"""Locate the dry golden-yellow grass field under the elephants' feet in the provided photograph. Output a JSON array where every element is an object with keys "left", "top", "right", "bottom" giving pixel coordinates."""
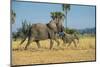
[{"left": 12, "top": 37, "right": 96, "bottom": 65}]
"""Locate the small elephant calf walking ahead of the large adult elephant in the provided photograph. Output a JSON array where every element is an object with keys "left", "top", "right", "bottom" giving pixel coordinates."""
[{"left": 61, "top": 32, "right": 79, "bottom": 47}]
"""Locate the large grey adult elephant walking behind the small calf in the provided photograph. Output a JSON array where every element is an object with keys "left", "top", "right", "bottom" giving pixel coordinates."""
[{"left": 20, "top": 19, "right": 64, "bottom": 50}]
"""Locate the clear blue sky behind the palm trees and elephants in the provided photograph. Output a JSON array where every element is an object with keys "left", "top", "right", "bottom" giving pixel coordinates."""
[{"left": 11, "top": 1, "right": 95, "bottom": 31}]
